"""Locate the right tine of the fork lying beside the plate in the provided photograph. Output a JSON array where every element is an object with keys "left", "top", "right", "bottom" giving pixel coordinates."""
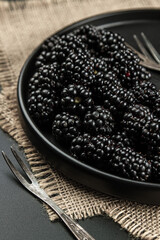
[{"left": 11, "top": 147, "right": 35, "bottom": 182}]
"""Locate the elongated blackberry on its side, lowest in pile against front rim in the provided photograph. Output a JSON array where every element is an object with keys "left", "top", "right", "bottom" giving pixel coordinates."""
[{"left": 108, "top": 147, "right": 151, "bottom": 181}]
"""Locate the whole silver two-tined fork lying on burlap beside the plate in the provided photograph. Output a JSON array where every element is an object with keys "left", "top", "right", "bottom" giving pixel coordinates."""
[{"left": 2, "top": 147, "right": 95, "bottom": 240}]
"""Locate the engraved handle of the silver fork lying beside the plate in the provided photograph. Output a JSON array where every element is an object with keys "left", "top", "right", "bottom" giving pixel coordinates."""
[{"left": 38, "top": 194, "right": 95, "bottom": 240}]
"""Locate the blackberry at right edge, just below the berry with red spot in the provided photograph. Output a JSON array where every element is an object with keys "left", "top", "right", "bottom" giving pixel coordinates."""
[{"left": 133, "top": 81, "right": 158, "bottom": 107}]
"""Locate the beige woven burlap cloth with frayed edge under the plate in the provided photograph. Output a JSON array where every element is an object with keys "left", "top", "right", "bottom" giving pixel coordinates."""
[{"left": 0, "top": 0, "right": 160, "bottom": 240}]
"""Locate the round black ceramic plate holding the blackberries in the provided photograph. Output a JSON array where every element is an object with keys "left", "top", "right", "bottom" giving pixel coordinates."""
[{"left": 18, "top": 10, "right": 160, "bottom": 204}]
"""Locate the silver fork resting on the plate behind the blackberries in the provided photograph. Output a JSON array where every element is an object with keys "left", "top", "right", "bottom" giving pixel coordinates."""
[{"left": 126, "top": 32, "right": 160, "bottom": 71}]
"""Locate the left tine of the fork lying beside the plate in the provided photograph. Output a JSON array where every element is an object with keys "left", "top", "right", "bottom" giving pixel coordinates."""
[{"left": 2, "top": 151, "right": 30, "bottom": 189}]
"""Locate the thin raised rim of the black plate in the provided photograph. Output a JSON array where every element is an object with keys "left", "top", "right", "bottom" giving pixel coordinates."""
[{"left": 17, "top": 8, "right": 160, "bottom": 193}]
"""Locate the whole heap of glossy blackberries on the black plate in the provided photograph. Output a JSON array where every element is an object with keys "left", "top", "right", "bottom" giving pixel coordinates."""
[{"left": 27, "top": 25, "right": 160, "bottom": 182}]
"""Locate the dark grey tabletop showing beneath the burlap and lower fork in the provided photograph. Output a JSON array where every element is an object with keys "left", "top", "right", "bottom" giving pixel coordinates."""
[{"left": 0, "top": 130, "right": 131, "bottom": 240}]
